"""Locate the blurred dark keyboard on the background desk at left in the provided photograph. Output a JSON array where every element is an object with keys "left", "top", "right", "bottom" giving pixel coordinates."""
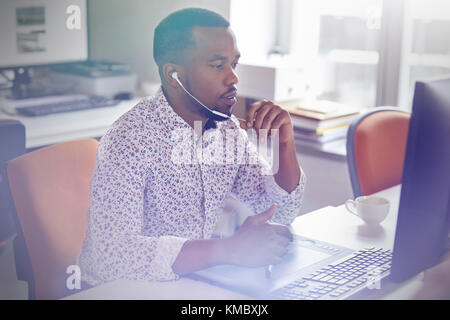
[{"left": 15, "top": 96, "right": 120, "bottom": 117}]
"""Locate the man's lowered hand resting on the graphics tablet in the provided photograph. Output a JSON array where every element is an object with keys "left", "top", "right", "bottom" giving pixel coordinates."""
[{"left": 225, "top": 205, "right": 293, "bottom": 267}]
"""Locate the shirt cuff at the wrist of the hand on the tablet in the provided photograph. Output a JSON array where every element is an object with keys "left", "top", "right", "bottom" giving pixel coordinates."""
[{"left": 150, "top": 236, "right": 188, "bottom": 280}]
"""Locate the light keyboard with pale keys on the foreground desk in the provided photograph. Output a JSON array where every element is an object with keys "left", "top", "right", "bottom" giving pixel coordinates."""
[{"left": 267, "top": 248, "right": 392, "bottom": 300}]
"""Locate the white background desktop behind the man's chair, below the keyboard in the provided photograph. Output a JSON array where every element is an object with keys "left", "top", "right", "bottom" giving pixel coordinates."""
[{"left": 0, "top": 98, "right": 141, "bottom": 149}]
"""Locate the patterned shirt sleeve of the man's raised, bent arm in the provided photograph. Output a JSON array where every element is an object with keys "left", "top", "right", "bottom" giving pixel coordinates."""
[{"left": 233, "top": 127, "right": 306, "bottom": 225}]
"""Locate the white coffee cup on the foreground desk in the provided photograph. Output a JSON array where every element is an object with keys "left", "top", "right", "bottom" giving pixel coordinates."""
[{"left": 345, "top": 196, "right": 390, "bottom": 225}]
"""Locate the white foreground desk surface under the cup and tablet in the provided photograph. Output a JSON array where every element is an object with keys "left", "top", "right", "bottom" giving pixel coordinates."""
[{"left": 66, "top": 186, "right": 421, "bottom": 300}]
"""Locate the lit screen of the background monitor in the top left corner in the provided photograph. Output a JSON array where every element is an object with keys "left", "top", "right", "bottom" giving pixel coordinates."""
[{"left": 0, "top": 0, "right": 88, "bottom": 69}]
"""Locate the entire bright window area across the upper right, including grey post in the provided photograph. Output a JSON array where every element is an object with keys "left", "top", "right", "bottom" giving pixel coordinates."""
[{"left": 231, "top": 0, "right": 450, "bottom": 110}]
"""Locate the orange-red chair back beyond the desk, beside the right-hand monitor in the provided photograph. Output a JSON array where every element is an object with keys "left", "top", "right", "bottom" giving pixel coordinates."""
[{"left": 347, "top": 107, "right": 410, "bottom": 198}]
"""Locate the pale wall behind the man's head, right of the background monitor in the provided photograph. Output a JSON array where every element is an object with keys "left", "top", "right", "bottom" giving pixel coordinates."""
[{"left": 88, "top": 0, "right": 230, "bottom": 86}]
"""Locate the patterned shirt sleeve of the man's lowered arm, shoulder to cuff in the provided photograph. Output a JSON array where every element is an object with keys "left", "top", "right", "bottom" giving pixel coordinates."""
[{"left": 78, "top": 128, "right": 187, "bottom": 285}]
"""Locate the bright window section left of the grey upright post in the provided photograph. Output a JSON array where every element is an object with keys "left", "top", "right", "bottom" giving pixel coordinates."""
[{"left": 290, "top": 0, "right": 382, "bottom": 107}]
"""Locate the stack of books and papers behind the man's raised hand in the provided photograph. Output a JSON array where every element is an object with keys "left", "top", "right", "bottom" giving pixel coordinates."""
[{"left": 282, "top": 101, "right": 360, "bottom": 149}]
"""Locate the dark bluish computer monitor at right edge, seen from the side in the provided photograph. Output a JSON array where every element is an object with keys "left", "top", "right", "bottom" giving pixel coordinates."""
[{"left": 390, "top": 76, "right": 450, "bottom": 282}]
